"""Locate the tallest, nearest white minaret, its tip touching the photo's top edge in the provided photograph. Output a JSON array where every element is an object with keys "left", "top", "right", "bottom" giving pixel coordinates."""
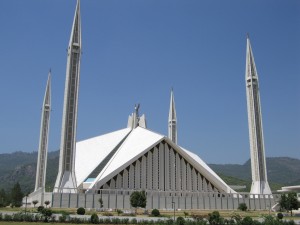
[{"left": 54, "top": 0, "right": 81, "bottom": 193}]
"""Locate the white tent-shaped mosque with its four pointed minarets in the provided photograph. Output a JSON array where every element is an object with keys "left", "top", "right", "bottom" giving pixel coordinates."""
[{"left": 24, "top": 0, "right": 272, "bottom": 208}]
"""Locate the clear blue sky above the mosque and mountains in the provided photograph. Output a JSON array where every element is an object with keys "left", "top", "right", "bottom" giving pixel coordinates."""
[{"left": 0, "top": 0, "right": 300, "bottom": 163}]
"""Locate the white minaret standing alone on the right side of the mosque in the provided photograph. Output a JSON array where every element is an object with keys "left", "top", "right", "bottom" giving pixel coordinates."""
[{"left": 246, "top": 35, "right": 272, "bottom": 194}]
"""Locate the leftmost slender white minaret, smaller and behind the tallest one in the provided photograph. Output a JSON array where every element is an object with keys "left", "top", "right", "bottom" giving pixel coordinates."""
[{"left": 34, "top": 70, "right": 51, "bottom": 195}]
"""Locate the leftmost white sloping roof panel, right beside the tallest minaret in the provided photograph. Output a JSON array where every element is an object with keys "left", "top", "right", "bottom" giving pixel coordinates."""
[{"left": 75, "top": 128, "right": 131, "bottom": 185}]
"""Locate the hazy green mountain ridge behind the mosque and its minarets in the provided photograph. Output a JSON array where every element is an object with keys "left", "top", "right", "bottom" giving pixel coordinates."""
[{"left": 0, "top": 151, "right": 300, "bottom": 193}]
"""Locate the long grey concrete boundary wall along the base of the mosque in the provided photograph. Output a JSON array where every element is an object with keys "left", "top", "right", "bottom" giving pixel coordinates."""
[{"left": 51, "top": 189, "right": 280, "bottom": 210}]
